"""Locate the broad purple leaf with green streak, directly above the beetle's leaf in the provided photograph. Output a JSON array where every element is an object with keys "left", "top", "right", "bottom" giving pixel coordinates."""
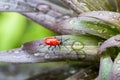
[{"left": 55, "top": 11, "right": 120, "bottom": 39}]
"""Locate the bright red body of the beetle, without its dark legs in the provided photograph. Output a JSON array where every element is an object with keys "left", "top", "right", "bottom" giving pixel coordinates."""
[{"left": 45, "top": 37, "right": 61, "bottom": 46}]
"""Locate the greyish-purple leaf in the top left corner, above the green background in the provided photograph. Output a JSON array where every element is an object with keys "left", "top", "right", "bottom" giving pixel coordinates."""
[{"left": 0, "top": 0, "right": 38, "bottom": 12}]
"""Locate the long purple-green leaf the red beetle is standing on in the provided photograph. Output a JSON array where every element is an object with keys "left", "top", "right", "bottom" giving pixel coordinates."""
[{"left": 0, "top": 35, "right": 102, "bottom": 63}]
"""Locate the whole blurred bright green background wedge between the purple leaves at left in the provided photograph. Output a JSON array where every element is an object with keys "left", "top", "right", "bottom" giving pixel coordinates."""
[{"left": 0, "top": 12, "right": 56, "bottom": 50}]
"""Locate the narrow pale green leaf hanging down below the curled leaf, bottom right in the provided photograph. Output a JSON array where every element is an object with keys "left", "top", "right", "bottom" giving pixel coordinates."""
[{"left": 98, "top": 53, "right": 113, "bottom": 80}]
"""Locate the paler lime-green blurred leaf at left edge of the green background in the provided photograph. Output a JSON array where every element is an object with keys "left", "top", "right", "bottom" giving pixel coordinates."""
[{"left": 0, "top": 13, "right": 27, "bottom": 50}]
